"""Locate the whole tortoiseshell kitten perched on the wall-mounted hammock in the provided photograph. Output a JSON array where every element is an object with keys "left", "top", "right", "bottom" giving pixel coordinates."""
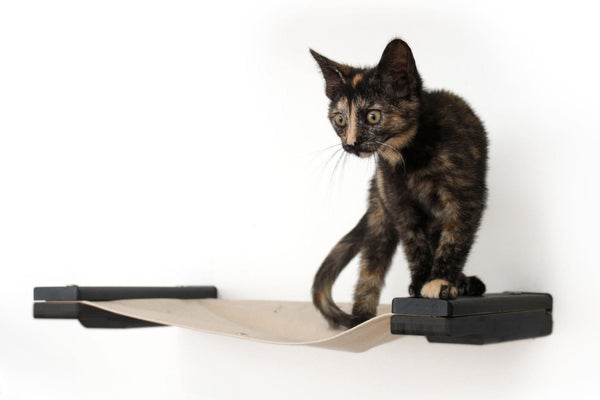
[{"left": 311, "top": 39, "right": 487, "bottom": 327}]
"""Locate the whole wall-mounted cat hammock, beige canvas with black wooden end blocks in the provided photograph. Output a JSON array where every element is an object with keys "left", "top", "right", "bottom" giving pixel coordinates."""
[{"left": 34, "top": 286, "right": 552, "bottom": 352}]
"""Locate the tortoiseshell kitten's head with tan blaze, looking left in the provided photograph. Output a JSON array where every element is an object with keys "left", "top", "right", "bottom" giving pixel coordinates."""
[{"left": 310, "top": 39, "right": 422, "bottom": 160}]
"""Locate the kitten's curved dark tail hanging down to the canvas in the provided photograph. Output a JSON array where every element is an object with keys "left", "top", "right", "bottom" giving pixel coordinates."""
[{"left": 312, "top": 214, "right": 367, "bottom": 328}]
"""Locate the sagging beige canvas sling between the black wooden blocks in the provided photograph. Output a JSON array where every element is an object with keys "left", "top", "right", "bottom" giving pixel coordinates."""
[{"left": 80, "top": 299, "right": 400, "bottom": 352}]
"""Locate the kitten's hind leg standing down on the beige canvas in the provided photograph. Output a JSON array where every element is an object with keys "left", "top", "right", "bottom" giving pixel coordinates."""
[{"left": 352, "top": 196, "right": 398, "bottom": 326}]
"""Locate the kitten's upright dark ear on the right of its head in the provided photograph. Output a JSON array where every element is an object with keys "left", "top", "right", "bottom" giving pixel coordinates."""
[{"left": 376, "top": 39, "right": 422, "bottom": 97}]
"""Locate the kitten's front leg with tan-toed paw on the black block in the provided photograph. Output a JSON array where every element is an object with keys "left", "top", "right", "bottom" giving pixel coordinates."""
[{"left": 421, "top": 190, "right": 485, "bottom": 299}]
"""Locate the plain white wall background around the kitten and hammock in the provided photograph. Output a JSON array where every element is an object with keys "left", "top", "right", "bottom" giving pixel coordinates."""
[{"left": 0, "top": 0, "right": 600, "bottom": 399}]
